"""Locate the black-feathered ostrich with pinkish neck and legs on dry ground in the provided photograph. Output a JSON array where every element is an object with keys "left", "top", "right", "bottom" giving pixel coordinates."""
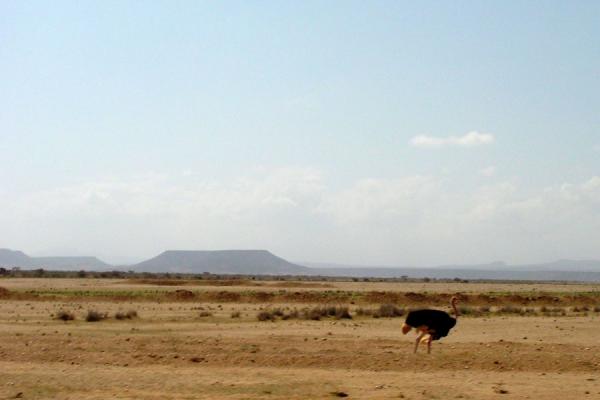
[{"left": 402, "top": 297, "right": 458, "bottom": 354}]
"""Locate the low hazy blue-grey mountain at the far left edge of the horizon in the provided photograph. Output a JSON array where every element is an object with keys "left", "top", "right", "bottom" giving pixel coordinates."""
[{"left": 0, "top": 249, "right": 111, "bottom": 270}]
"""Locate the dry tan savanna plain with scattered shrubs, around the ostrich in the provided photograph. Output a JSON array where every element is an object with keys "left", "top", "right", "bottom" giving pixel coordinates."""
[{"left": 0, "top": 278, "right": 600, "bottom": 399}]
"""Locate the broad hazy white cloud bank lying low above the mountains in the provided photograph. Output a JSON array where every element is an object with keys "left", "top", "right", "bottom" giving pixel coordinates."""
[{"left": 0, "top": 168, "right": 600, "bottom": 265}]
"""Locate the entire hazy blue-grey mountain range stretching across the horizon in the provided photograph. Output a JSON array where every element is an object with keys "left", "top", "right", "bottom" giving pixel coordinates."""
[{"left": 0, "top": 249, "right": 600, "bottom": 282}]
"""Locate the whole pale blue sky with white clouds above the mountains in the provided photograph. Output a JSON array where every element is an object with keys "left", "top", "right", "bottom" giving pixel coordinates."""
[{"left": 0, "top": 1, "right": 600, "bottom": 266}]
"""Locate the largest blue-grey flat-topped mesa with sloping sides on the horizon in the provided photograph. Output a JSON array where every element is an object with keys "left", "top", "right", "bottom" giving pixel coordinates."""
[{"left": 133, "top": 250, "right": 310, "bottom": 275}]
